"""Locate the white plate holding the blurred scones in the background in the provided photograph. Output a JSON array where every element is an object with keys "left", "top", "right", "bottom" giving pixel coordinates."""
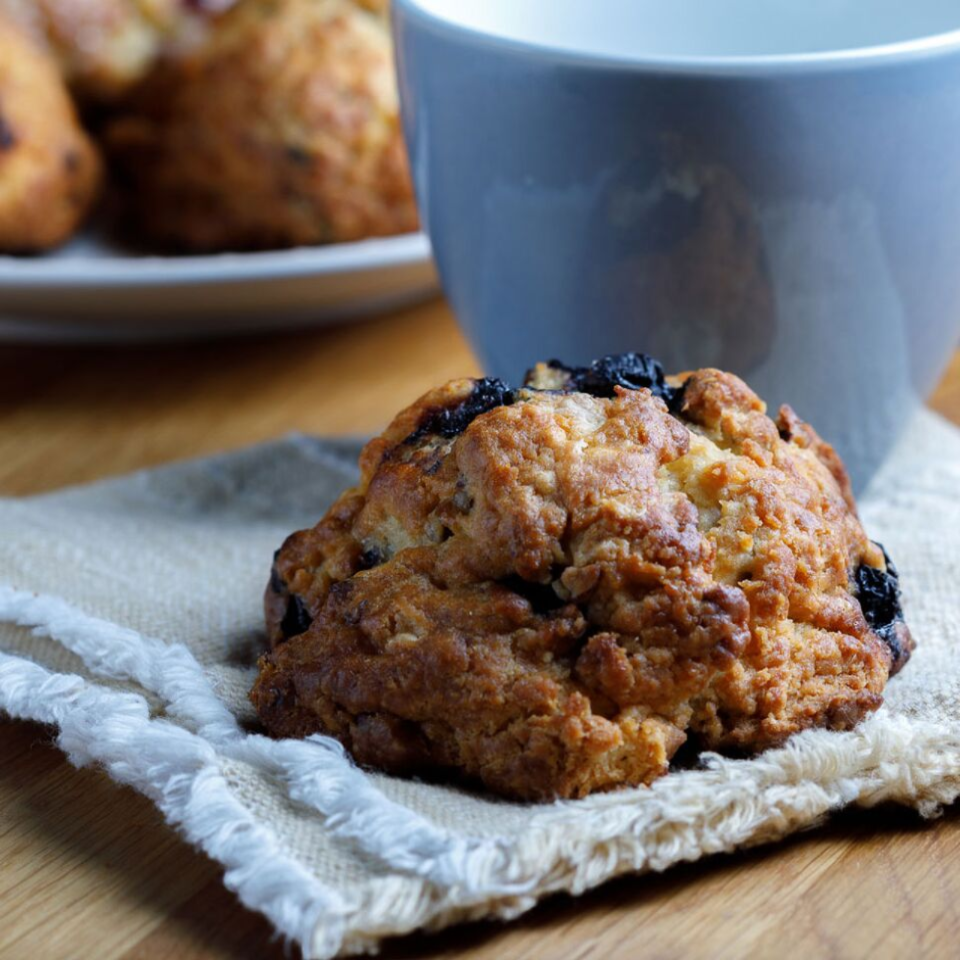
[{"left": 0, "top": 234, "right": 438, "bottom": 340}]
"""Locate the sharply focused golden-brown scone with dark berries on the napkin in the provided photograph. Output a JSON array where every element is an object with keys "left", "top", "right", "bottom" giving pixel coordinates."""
[{"left": 251, "top": 354, "right": 913, "bottom": 800}]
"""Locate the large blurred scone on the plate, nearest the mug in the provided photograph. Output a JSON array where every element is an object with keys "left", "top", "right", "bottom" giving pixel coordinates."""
[{"left": 108, "top": 0, "right": 417, "bottom": 251}]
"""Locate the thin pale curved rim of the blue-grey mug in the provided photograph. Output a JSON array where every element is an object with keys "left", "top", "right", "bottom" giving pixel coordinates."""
[{"left": 391, "top": 0, "right": 960, "bottom": 76}]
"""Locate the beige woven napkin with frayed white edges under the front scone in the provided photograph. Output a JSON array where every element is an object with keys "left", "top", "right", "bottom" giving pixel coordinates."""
[{"left": 0, "top": 414, "right": 960, "bottom": 957}]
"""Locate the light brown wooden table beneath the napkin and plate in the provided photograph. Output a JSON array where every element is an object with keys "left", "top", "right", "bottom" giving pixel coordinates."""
[{"left": 0, "top": 302, "right": 960, "bottom": 960}]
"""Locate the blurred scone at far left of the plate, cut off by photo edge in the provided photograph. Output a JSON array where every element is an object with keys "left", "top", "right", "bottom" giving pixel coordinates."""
[{"left": 0, "top": 18, "right": 101, "bottom": 253}]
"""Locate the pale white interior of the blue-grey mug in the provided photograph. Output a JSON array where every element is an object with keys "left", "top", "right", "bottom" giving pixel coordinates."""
[{"left": 405, "top": 0, "right": 960, "bottom": 60}]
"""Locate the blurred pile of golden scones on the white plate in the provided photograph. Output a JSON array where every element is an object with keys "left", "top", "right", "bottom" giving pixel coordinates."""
[{"left": 0, "top": 0, "right": 417, "bottom": 253}]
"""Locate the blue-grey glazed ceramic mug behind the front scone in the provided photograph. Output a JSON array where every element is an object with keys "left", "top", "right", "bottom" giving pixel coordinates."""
[{"left": 394, "top": 0, "right": 960, "bottom": 486}]
